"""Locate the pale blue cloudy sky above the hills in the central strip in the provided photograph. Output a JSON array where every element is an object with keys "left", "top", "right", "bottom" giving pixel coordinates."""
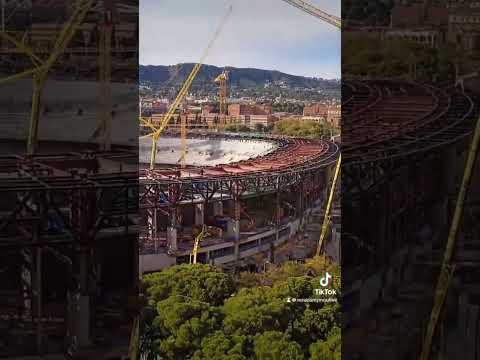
[{"left": 140, "top": 0, "right": 341, "bottom": 78}]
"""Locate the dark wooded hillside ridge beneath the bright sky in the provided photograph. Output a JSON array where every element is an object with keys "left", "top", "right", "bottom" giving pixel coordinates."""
[{"left": 140, "top": 64, "right": 340, "bottom": 90}]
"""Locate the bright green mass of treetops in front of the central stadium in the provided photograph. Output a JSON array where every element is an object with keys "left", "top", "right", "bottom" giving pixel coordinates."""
[{"left": 142, "top": 258, "right": 340, "bottom": 360}]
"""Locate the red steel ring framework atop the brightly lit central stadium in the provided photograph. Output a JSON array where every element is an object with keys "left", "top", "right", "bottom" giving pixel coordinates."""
[{"left": 139, "top": 133, "right": 339, "bottom": 252}]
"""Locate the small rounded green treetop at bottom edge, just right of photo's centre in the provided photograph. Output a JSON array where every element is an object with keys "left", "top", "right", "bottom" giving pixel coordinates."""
[{"left": 254, "top": 331, "right": 305, "bottom": 360}]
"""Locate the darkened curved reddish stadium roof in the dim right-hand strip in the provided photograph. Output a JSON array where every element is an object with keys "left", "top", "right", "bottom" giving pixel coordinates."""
[{"left": 342, "top": 80, "right": 478, "bottom": 164}]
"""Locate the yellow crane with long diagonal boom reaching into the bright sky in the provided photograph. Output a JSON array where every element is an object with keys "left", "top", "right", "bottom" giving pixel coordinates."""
[{"left": 140, "top": 6, "right": 232, "bottom": 169}]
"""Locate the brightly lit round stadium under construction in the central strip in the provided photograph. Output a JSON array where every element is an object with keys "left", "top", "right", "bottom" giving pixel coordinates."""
[{"left": 139, "top": 132, "right": 339, "bottom": 272}]
